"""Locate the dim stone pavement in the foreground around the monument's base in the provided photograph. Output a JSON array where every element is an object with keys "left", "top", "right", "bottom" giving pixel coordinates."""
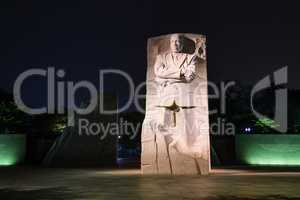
[{"left": 0, "top": 167, "right": 300, "bottom": 200}]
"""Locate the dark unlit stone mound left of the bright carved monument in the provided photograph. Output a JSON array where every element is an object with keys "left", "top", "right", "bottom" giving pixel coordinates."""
[{"left": 43, "top": 94, "right": 117, "bottom": 167}]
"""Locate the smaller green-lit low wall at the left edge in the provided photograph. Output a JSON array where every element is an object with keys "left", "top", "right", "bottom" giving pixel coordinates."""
[{"left": 0, "top": 134, "right": 26, "bottom": 166}]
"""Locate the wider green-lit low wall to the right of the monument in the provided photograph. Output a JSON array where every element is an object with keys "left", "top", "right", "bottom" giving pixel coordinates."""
[{"left": 235, "top": 134, "right": 300, "bottom": 166}]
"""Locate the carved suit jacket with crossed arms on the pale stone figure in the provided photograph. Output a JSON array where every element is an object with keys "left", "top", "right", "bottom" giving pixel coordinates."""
[{"left": 154, "top": 53, "right": 199, "bottom": 107}]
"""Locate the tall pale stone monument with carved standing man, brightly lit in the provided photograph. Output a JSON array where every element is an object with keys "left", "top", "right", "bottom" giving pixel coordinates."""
[{"left": 141, "top": 34, "right": 210, "bottom": 175}]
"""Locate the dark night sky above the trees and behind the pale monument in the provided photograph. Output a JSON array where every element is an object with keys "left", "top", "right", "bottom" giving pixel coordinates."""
[{"left": 0, "top": 0, "right": 300, "bottom": 108}]
